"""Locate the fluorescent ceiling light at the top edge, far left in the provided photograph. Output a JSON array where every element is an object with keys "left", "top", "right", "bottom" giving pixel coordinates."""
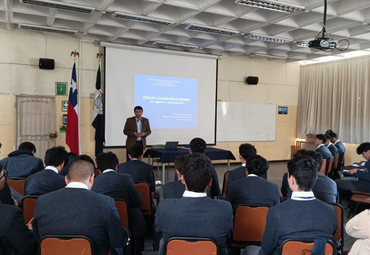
[{"left": 19, "top": 0, "right": 95, "bottom": 14}]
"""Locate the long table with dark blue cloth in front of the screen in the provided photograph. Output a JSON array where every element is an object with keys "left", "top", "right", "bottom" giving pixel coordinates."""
[{"left": 144, "top": 148, "right": 235, "bottom": 185}]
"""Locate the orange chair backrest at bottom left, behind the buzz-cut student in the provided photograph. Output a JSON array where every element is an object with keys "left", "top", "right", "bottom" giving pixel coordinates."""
[{"left": 39, "top": 236, "right": 94, "bottom": 255}]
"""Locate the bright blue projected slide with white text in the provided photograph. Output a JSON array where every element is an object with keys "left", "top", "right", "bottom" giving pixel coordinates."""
[{"left": 135, "top": 74, "right": 198, "bottom": 129}]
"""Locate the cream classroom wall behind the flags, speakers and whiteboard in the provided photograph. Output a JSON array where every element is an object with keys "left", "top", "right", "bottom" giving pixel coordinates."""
[{"left": 0, "top": 29, "right": 359, "bottom": 162}]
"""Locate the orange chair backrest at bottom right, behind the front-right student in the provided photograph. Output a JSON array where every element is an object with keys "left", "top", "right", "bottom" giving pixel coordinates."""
[{"left": 279, "top": 239, "right": 337, "bottom": 255}]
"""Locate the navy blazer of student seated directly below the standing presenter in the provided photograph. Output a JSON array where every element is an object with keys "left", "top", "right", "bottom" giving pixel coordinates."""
[{"left": 118, "top": 160, "right": 155, "bottom": 191}]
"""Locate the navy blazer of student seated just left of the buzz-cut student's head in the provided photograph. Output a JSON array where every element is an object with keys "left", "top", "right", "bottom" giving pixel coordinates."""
[{"left": 24, "top": 169, "right": 66, "bottom": 196}]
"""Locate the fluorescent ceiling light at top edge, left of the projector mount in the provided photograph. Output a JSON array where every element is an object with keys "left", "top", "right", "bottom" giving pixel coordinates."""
[{"left": 235, "top": 0, "right": 305, "bottom": 13}]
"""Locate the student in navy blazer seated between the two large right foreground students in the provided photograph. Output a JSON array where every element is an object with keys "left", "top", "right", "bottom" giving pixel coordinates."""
[{"left": 227, "top": 155, "right": 280, "bottom": 208}]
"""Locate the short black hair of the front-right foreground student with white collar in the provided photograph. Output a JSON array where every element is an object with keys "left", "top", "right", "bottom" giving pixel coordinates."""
[{"left": 288, "top": 156, "right": 319, "bottom": 191}]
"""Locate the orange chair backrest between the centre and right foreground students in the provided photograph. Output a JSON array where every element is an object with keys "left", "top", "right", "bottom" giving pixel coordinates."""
[{"left": 232, "top": 205, "right": 269, "bottom": 245}]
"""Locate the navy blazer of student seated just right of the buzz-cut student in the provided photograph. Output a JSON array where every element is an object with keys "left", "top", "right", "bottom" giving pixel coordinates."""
[{"left": 92, "top": 171, "right": 146, "bottom": 238}]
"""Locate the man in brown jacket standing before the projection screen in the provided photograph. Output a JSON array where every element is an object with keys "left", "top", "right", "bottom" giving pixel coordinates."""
[{"left": 123, "top": 106, "right": 152, "bottom": 161}]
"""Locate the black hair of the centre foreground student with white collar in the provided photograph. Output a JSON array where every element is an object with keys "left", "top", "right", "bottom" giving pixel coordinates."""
[{"left": 183, "top": 153, "right": 212, "bottom": 192}]
